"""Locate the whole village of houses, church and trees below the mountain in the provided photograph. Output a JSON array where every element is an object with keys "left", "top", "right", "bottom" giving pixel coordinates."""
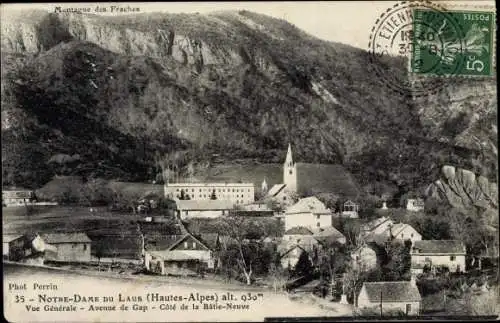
[{"left": 2, "top": 144, "right": 498, "bottom": 316}]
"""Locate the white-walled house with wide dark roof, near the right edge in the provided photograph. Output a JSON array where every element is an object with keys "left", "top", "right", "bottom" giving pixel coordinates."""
[{"left": 410, "top": 240, "right": 466, "bottom": 273}]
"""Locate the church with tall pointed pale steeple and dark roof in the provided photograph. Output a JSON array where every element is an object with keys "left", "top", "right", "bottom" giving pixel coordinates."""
[{"left": 261, "top": 144, "right": 359, "bottom": 204}]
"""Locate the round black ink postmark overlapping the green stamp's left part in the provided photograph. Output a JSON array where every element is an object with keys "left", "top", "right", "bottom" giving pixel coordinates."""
[{"left": 368, "top": 1, "right": 465, "bottom": 97}]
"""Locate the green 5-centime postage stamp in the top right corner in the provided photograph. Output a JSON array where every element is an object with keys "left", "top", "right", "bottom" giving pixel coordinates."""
[{"left": 411, "top": 8, "right": 496, "bottom": 76}]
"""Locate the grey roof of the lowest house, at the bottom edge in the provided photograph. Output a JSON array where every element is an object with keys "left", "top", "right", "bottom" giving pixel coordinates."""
[{"left": 363, "top": 281, "right": 422, "bottom": 303}]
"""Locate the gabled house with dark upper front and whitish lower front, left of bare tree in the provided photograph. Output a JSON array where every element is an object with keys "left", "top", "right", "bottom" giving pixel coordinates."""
[{"left": 144, "top": 233, "right": 215, "bottom": 276}]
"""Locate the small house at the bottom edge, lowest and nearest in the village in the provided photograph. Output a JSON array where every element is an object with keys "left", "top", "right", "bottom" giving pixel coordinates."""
[{"left": 357, "top": 278, "right": 422, "bottom": 315}]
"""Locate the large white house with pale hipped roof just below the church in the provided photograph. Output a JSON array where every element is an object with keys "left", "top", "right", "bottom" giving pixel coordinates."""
[{"left": 285, "top": 196, "right": 332, "bottom": 230}]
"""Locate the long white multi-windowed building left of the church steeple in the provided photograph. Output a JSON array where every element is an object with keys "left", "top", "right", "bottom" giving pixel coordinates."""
[{"left": 165, "top": 183, "right": 255, "bottom": 205}]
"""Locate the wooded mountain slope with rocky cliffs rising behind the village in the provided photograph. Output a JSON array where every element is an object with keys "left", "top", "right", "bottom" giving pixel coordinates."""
[{"left": 1, "top": 11, "right": 497, "bottom": 195}]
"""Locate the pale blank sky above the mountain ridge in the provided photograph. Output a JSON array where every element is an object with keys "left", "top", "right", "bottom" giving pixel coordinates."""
[{"left": 2, "top": 0, "right": 494, "bottom": 49}]
